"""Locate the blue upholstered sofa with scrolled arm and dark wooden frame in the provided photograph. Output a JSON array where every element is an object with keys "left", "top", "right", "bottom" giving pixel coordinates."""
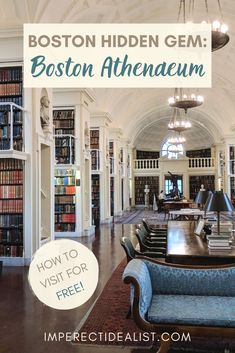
[{"left": 123, "top": 259, "right": 235, "bottom": 352}]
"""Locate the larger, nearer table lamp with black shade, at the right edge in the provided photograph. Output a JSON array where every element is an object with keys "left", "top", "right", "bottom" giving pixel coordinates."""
[{"left": 204, "top": 191, "right": 234, "bottom": 235}]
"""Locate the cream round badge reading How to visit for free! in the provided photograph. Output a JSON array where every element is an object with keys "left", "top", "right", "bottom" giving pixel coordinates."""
[{"left": 28, "top": 239, "right": 99, "bottom": 310}]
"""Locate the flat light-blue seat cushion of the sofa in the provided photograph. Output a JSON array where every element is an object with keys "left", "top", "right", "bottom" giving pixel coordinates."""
[{"left": 147, "top": 294, "right": 235, "bottom": 327}]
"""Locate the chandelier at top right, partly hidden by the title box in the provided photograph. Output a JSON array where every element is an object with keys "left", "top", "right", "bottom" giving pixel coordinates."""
[{"left": 178, "top": 0, "right": 229, "bottom": 51}]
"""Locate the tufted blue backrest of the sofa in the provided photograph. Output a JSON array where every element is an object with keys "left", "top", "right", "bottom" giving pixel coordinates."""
[{"left": 144, "top": 260, "right": 235, "bottom": 297}]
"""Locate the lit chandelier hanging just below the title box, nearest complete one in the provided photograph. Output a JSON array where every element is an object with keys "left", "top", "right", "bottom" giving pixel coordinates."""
[{"left": 168, "top": 88, "right": 204, "bottom": 113}]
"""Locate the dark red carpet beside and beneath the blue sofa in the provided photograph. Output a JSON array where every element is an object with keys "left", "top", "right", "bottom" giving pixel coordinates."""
[{"left": 74, "top": 260, "right": 235, "bottom": 353}]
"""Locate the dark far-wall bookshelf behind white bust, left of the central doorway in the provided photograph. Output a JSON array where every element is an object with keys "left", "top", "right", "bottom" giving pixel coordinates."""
[{"left": 135, "top": 176, "right": 159, "bottom": 206}]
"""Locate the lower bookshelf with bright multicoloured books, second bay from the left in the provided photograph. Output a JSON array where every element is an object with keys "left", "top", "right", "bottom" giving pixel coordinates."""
[{"left": 54, "top": 168, "right": 76, "bottom": 232}]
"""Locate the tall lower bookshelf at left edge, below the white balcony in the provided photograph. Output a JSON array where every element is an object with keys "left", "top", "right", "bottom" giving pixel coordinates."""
[{"left": 0, "top": 159, "right": 24, "bottom": 257}]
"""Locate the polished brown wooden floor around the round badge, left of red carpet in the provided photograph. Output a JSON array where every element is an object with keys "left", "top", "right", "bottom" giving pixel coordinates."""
[{"left": 0, "top": 224, "right": 158, "bottom": 353}]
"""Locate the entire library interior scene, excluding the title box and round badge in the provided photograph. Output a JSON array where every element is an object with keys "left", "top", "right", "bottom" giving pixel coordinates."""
[{"left": 0, "top": 0, "right": 235, "bottom": 353}]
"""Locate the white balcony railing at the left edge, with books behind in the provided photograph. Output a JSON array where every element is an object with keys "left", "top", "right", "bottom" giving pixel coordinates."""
[{"left": 0, "top": 102, "right": 24, "bottom": 152}]
